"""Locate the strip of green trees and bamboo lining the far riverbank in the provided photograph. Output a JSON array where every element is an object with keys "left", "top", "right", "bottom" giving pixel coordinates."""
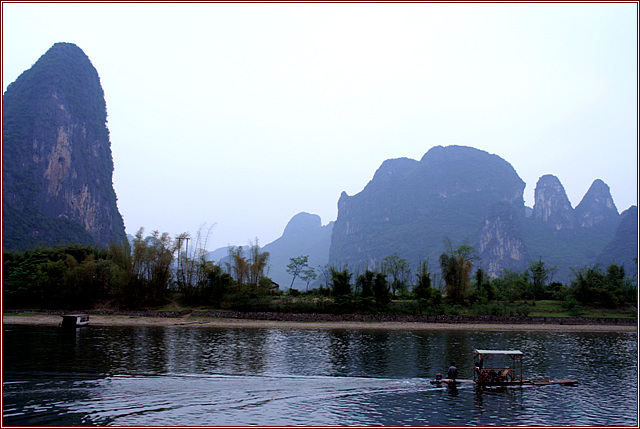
[{"left": 3, "top": 228, "right": 637, "bottom": 316}]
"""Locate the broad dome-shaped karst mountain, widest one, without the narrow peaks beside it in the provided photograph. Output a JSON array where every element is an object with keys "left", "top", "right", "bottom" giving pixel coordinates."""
[{"left": 329, "top": 146, "right": 528, "bottom": 274}]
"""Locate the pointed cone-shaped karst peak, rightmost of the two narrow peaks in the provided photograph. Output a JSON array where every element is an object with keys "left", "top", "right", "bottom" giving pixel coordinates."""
[{"left": 575, "top": 179, "right": 620, "bottom": 228}]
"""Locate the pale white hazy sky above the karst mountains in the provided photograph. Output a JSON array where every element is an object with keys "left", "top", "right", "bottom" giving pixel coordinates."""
[{"left": 2, "top": 3, "right": 638, "bottom": 250}]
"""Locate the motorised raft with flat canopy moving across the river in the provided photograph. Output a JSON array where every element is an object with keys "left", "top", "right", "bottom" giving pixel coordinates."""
[{"left": 431, "top": 350, "right": 578, "bottom": 387}]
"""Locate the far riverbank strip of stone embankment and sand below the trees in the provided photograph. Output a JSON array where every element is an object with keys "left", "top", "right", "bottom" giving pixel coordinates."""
[{"left": 2, "top": 311, "right": 638, "bottom": 332}]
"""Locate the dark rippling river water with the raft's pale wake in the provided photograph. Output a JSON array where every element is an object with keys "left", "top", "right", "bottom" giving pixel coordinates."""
[{"left": 2, "top": 325, "right": 638, "bottom": 426}]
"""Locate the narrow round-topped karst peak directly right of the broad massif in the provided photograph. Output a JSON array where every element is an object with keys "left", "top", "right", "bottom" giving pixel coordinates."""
[{"left": 533, "top": 174, "right": 575, "bottom": 231}]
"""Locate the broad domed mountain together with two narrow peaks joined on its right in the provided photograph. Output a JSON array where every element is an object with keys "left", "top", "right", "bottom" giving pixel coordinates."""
[{"left": 329, "top": 146, "right": 637, "bottom": 281}]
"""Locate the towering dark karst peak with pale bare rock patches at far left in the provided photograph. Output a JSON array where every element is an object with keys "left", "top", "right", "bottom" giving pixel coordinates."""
[{"left": 2, "top": 43, "right": 125, "bottom": 251}]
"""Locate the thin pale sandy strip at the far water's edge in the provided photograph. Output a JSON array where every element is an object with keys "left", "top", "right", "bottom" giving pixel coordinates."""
[{"left": 2, "top": 314, "right": 637, "bottom": 332}]
